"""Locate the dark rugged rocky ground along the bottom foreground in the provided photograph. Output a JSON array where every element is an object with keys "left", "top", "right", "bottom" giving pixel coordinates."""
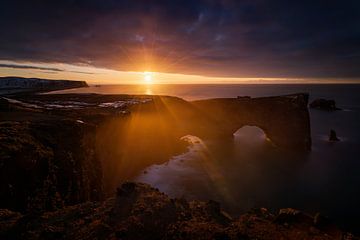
[{"left": 0, "top": 182, "right": 358, "bottom": 240}]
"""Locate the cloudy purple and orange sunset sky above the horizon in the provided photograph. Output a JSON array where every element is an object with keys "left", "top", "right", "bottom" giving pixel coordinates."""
[{"left": 0, "top": 0, "right": 360, "bottom": 84}]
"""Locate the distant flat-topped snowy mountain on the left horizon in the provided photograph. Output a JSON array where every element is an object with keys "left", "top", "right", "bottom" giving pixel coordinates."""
[{"left": 0, "top": 77, "right": 88, "bottom": 91}]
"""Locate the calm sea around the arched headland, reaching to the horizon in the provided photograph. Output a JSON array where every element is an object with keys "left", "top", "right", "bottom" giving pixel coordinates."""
[{"left": 54, "top": 85, "right": 360, "bottom": 233}]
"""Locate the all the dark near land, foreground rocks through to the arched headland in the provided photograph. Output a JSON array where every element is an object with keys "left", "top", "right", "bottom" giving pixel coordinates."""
[{"left": 0, "top": 94, "right": 355, "bottom": 239}]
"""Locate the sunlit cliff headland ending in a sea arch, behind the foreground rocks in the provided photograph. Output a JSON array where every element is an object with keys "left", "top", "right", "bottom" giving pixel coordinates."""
[{"left": 0, "top": 94, "right": 311, "bottom": 211}]
